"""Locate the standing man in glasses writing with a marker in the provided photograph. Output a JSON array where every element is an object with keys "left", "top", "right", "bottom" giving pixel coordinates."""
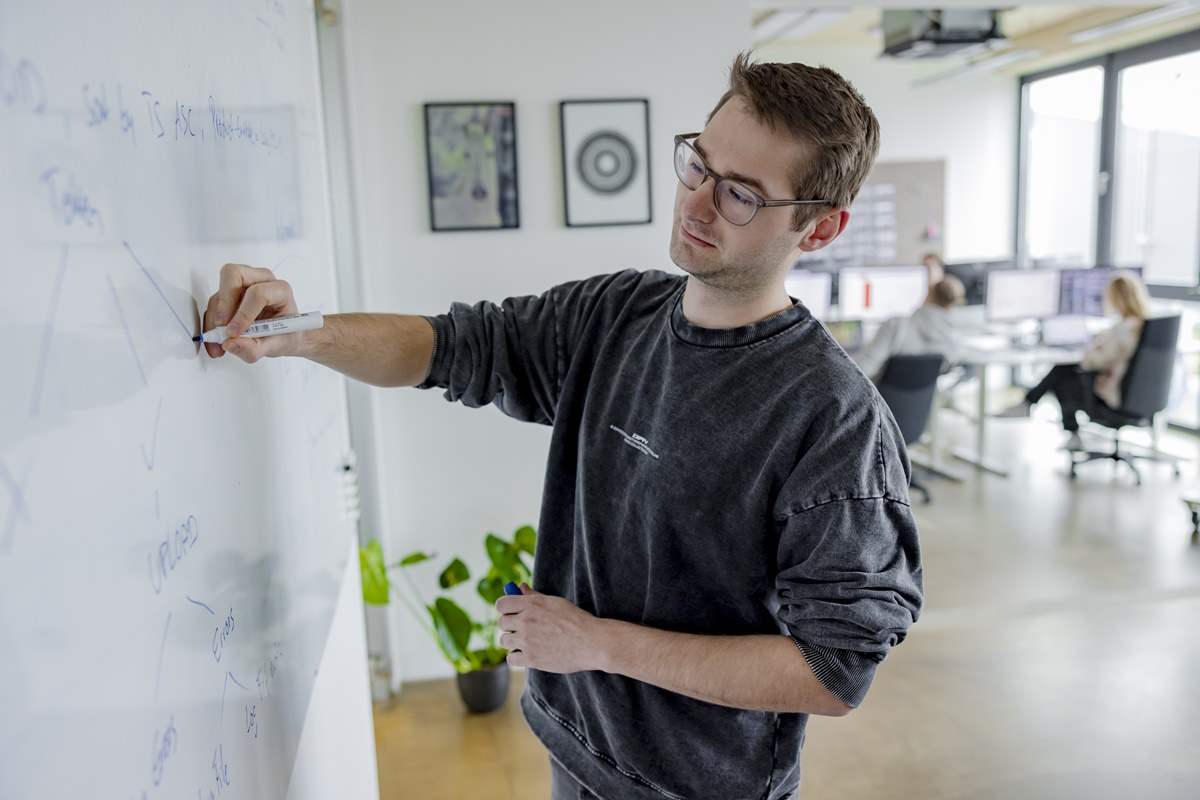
[{"left": 205, "top": 56, "right": 922, "bottom": 800}]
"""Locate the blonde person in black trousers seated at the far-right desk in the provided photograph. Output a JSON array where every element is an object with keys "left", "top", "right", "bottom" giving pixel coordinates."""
[{"left": 996, "top": 271, "right": 1150, "bottom": 450}]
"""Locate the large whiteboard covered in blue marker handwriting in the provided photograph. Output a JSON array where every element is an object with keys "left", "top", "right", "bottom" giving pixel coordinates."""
[{"left": 0, "top": 0, "right": 365, "bottom": 800}]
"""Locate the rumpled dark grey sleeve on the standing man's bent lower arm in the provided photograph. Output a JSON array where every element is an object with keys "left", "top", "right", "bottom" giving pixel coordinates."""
[{"left": 775, "top": 383, "right": 923, "bottom": 706}]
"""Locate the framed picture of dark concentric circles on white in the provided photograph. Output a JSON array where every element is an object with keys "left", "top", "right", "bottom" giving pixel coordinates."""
[{"left": 559, "top": 100, "right": 652, "bottom": 228}]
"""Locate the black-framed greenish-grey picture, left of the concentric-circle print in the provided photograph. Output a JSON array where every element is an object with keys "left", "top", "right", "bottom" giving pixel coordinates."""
[{"left": 425, "top": 103, "right": 521, "bottom": 230}]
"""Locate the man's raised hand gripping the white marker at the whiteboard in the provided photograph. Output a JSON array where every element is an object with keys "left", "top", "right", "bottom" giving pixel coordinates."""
[{"left": 203, "top": 264, "right": 304, "bottom": 363}]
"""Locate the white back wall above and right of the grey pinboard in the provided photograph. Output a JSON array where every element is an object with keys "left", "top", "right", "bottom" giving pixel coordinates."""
[{"left": 758, "top": 42, "right": 1019, "bottom": 261}]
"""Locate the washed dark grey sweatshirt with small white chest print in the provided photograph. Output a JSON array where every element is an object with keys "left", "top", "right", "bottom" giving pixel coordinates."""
[{"left": 422, "top": 271, "right": 922, "bottom": 800}]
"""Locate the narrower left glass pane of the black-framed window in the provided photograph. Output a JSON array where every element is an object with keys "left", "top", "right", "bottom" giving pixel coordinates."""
[{"left": 1024, "top": 66, "right": 1104, "bottom": 264}]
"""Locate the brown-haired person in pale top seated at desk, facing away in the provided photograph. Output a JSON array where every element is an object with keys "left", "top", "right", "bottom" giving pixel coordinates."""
[{"left": 854, "top": 275, "right": 966, "bottom": 381}]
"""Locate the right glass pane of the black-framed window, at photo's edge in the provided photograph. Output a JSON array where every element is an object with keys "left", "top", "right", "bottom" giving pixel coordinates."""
[{"left": 1112, "top": 53, "right": 1200, "bottom": 285}]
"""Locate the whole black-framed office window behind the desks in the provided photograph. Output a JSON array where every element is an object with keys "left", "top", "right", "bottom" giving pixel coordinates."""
[{"left": 1016, "top": 30, "right": 1200, "bottom": 431}]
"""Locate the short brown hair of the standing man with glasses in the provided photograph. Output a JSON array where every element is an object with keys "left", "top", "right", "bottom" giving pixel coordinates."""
[{"left": 709, "top": 53, "right": 880, "bottom": 229}]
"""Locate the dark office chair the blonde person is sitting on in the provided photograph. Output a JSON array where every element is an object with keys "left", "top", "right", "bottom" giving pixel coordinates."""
[{"left": 1070, "top": 314, "right": 1180, "bottom": 486}]
